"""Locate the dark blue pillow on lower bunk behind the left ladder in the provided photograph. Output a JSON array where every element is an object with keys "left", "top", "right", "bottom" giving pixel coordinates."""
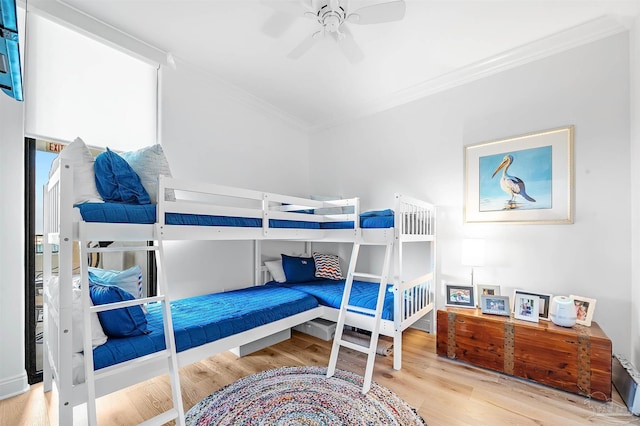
[{"left": 89, "top": 282, "right": 149, "bottom": 337}]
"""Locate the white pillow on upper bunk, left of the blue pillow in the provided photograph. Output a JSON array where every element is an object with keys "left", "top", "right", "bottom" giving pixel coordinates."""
[{"left": 49, "top": 138, "right": 103, "bottom": 205}]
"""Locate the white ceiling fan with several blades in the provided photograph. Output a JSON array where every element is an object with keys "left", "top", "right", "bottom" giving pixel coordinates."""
[{"left": 263, "top": 0, "right": 406, "bottom": 63}]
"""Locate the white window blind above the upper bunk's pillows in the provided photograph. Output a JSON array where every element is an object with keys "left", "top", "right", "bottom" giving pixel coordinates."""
[{"left": 24, "top": 12, "right": 157, "bottom": 150}]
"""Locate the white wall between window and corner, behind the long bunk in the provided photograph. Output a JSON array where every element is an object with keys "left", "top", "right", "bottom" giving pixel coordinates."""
[{"left": 161, "top": 62, "right": 310, "bottom": 297}]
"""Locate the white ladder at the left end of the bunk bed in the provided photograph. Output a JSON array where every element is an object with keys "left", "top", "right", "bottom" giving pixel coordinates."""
[{"left": 80, "top": 233, "right": 185, "bottom": 426}]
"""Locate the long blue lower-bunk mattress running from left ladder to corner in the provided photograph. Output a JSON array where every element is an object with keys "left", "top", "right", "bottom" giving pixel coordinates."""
[{"left": 93, "top": 286, "right": 318, "bottom": 370}]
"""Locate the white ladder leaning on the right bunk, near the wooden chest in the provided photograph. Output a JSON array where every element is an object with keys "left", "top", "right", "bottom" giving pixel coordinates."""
[{"left": 327, "top": 242, "right": 393, "bottom": 393}]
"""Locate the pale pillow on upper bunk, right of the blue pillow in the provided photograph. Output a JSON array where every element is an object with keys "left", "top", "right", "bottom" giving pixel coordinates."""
[{"left": 120, "top": 144, "right": 176, "bottom": 204}]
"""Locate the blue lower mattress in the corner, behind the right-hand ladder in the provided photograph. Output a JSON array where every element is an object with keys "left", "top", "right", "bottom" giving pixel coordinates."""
[{"left": 268, "top": 280, "right": 393, "bottom": 320}]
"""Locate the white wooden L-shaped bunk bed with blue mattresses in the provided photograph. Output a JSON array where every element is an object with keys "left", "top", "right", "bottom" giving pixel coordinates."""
[{"left": 43, "top": 141, "right": 435, "bottom": 424}]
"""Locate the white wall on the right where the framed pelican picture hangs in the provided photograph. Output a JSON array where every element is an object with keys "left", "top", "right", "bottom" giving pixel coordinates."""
[{"left": 310, "top": 33, "right": 631, "bottom": 354}]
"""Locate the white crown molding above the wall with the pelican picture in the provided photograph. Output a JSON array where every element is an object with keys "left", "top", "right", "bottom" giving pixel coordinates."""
[{"left": 309, "top": 16, "right": 631, "bottom": 133}]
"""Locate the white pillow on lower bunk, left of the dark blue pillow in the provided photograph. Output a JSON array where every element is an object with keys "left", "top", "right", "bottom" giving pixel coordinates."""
[{"left": 49, "top": 276, "right": 107, "bottom": 353}]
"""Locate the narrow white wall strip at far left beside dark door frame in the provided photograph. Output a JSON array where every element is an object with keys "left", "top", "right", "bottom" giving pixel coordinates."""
[{"left": 0, "top": 92, "right": 29, "bottom": 399}]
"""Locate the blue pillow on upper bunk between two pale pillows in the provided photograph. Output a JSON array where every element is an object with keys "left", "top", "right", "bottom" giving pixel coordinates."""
[{"left": 93, "top": 148, "right": 151, "bottom": 204}]
